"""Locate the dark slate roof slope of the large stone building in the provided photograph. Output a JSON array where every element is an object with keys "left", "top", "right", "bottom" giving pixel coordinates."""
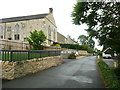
[{"left": 0, "top": 14, "right": 48, "bottom": 23}]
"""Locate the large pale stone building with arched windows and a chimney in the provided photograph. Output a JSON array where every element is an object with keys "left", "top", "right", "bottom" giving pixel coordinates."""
[{"left": 0, "top": 8, "right": 57, "bottom": 46}]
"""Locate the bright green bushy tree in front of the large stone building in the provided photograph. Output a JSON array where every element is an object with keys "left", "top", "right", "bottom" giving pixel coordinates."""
[{"left": 26, "top": 30, "right": 46, "bottom": 50}]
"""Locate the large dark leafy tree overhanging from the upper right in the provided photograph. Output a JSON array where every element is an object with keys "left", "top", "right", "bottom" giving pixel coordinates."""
[{"left": 72, "top": 2, "right": 120, "bottom": 54}]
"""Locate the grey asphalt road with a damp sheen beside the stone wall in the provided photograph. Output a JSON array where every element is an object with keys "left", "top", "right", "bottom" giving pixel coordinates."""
[{"left": 3, "top": 56, "right": 104, "bottom": 88}]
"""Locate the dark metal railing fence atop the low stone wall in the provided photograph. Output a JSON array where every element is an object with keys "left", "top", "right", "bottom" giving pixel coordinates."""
[{"left": 0, "top": 50, "right": 61, "bottom": 61}]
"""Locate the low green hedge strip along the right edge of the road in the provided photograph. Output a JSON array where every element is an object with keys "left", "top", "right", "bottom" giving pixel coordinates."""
[{"left": 98, "top": 61, "right": 120, "bottom": 89}]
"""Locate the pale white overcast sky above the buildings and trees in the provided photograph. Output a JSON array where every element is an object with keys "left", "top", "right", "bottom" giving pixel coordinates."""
[{"left": 0, "top": 0, "right": 102, "bottom": 50}]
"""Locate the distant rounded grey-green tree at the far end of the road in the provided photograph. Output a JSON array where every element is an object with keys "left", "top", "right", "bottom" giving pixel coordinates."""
[{"left": 78, "top": 35, "right": 95, "bottom": 48}]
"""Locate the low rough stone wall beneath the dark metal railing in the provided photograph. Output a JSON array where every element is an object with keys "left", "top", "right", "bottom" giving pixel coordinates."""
[{"left": 1, "top": 56, "right": 63, "bottom": 80}]
